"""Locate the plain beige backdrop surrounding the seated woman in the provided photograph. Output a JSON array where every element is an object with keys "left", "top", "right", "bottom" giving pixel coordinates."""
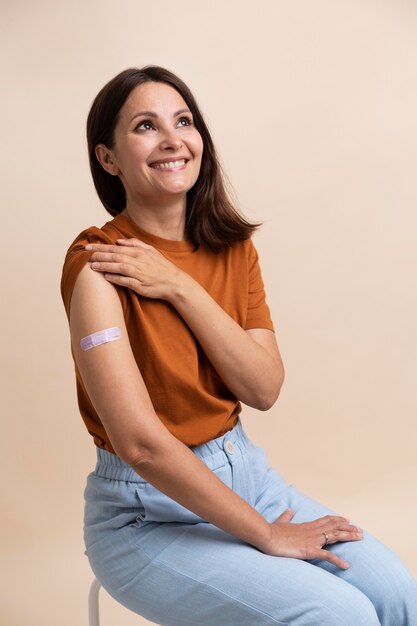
[{"left": 0, "top": 0, "right": 417, "bottom": 626}]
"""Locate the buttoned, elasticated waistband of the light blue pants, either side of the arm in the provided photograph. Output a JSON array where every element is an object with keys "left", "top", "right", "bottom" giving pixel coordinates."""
[{"left": 94, "top": 417, "right": 250, "bottom": 483}]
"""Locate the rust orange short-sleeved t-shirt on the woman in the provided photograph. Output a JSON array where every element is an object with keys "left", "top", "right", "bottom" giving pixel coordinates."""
[{"left": 61, "top": 215, "right": 274, "bottom": 453}]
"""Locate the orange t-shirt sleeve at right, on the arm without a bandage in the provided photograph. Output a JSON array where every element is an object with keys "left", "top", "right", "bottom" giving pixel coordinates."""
[{"left": 245, "top": 239, "right": 275, "bottom": 332}]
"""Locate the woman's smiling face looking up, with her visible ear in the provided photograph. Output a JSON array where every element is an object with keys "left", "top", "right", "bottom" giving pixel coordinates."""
[{"left": 96, "top": 82, "right": 203, "bottom": 202}]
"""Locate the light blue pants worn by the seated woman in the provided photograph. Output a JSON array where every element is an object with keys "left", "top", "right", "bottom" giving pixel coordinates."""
[{"left": 84, "top": 419, "right": 417, "bottom": 626}]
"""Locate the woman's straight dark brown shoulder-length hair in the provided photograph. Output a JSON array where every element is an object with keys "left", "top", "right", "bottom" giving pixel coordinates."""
[{"left": 87, "top": 65, "right": 260, "bottom": 252}]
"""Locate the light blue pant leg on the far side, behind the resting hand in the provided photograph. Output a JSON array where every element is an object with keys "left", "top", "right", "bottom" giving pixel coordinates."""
[{"left": 256, "top": 460, "right": 417, "bottom": 626}]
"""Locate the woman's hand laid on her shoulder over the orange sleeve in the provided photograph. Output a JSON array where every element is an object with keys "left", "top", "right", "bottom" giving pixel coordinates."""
[{"left": 86, "top": 238, "right": 190, "bottom": 301}]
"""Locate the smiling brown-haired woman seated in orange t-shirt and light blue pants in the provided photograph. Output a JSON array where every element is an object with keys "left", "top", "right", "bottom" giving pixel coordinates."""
[{"left": 61, "top": 66, "right": 417, "bottom": 626}]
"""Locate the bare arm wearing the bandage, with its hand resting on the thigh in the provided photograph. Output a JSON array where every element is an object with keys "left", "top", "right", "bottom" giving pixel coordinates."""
[{"left": 70, "top": 265, "right": 358, "bottom": 567}]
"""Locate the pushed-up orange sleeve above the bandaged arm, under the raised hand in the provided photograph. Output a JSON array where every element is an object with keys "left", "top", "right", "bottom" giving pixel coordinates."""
[{"left": 61, "top": 226, "right": 126, "bottom": 320}]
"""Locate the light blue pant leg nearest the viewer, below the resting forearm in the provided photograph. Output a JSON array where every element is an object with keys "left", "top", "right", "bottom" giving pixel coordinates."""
[{"left": 88, "top": 510, "right": 379, "bottom": 626}]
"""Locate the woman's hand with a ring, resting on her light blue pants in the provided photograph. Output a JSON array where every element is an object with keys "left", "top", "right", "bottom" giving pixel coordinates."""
[{"left": 262, "top": 509, "right": 363, "bottom": 569}]
